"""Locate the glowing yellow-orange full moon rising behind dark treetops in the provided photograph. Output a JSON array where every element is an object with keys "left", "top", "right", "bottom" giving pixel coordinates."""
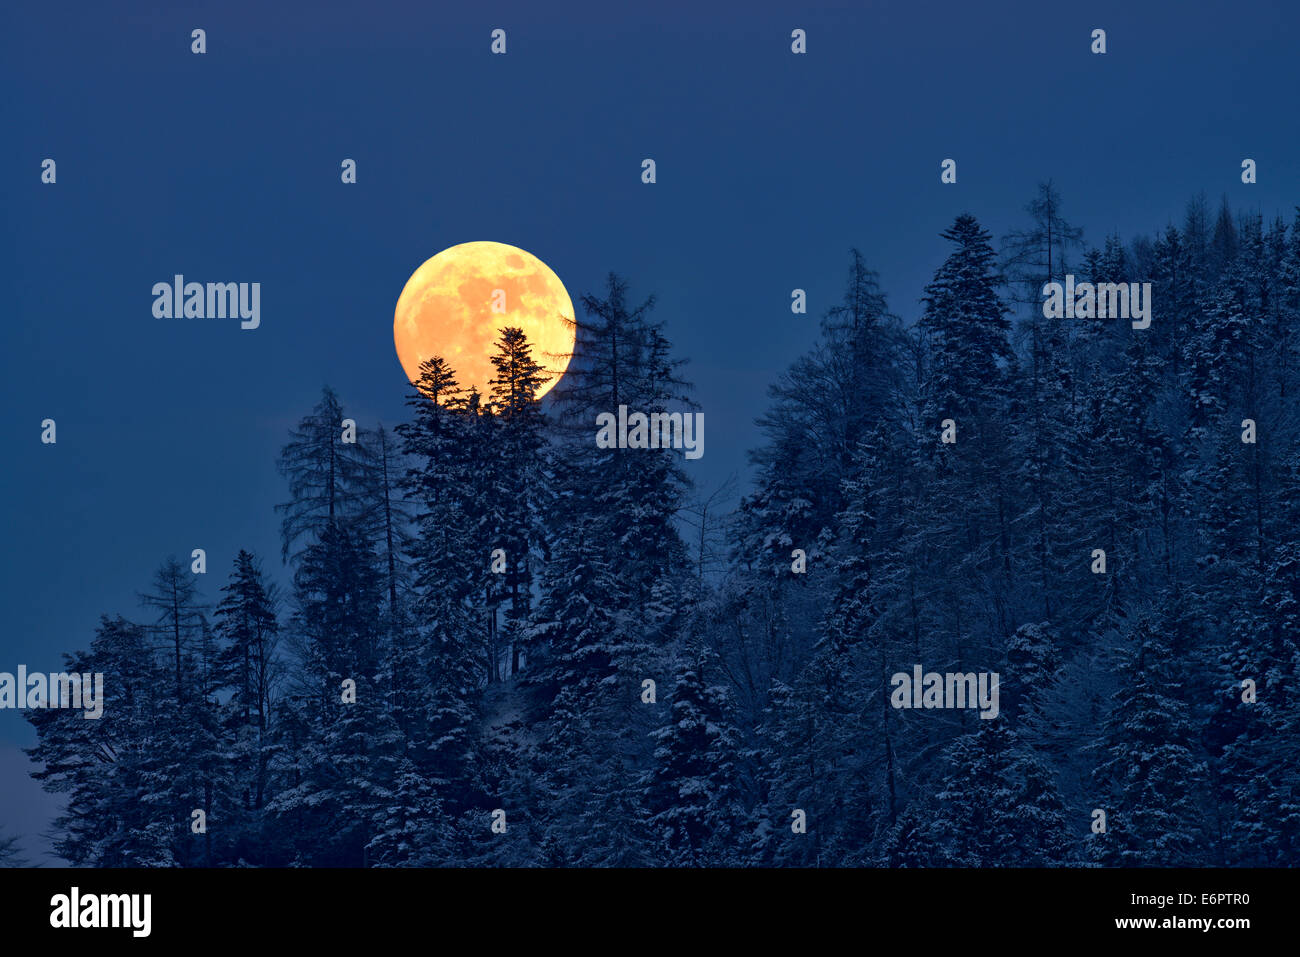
[{"left": 393, "top": 242, "right": 575, "bottom": 400}]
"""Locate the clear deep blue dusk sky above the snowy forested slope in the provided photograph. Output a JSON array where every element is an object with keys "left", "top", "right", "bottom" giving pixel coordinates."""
[{"left": 0, "top": 1, "right": 1300, "bottom": 846}]
